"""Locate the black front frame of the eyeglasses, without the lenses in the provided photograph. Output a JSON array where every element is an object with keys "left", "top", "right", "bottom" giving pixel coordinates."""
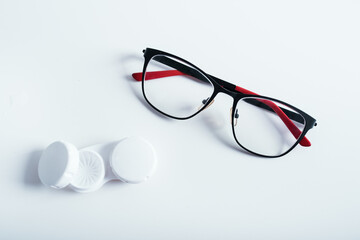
[{"left": 141, "top": 48, "right": 317, "bottom": 158}]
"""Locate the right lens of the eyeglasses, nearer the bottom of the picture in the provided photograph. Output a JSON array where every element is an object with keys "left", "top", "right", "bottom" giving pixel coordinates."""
[{"left": 233, "top": 97, "right": 305, "bottom": 157}]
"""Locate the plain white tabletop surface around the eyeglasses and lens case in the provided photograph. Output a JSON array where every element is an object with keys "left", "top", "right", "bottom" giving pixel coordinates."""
[{"left": 0, "top": 0, "right": 360, "bottom": 240}]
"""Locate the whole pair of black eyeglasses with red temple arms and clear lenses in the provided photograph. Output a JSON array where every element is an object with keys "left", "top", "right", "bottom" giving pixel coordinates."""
[{"left": 132, "top": 48, "right": 317, "bottom": 157}]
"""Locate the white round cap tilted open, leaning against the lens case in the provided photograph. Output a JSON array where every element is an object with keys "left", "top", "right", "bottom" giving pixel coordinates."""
[{"left": 38, "top": 141, "right": 79, "bottom": 188}]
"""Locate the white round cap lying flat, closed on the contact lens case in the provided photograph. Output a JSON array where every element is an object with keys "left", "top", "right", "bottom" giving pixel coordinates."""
[{"left": 110, "top": 137, "right": 157, "bottom": 183}]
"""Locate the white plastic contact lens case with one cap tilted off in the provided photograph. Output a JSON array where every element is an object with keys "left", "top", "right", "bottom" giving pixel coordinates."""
[{"left": 38, "top": 137, "right": 157, "bottom": 192}]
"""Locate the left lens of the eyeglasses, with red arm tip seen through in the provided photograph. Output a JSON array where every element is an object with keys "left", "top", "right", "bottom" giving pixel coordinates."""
[{"left": 143, "top": 55, "right": 214, "bottom": 118}]
